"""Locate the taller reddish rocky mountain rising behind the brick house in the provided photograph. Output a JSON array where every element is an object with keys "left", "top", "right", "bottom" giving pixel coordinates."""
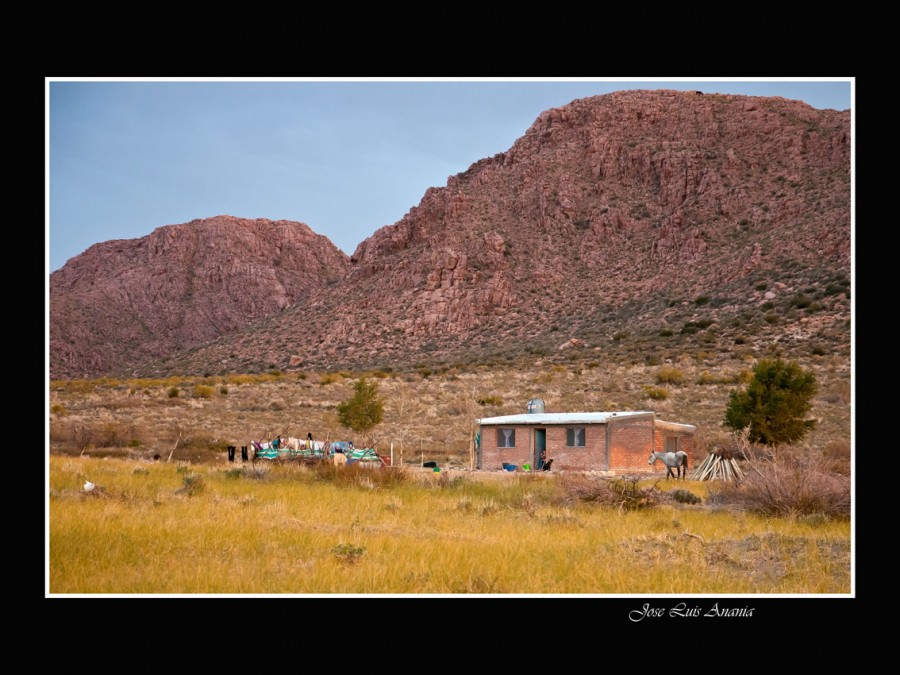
[{"left": 49, "top": 90, "right": 851, "bottom": 375}]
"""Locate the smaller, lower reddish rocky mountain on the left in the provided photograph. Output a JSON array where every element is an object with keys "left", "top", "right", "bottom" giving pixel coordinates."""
[{"left": 50, "top": 216, "right": 350, "bottom": 379}]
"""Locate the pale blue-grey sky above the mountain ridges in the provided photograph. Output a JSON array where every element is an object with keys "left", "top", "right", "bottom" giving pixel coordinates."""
[{"left": 45, "top": 77, "right": 855, "bottom": 272}]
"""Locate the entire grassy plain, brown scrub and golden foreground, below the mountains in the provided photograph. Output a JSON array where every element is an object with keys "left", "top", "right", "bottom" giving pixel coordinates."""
[{"left": 47, "top": 354, "right": 852, "bottom": 595}]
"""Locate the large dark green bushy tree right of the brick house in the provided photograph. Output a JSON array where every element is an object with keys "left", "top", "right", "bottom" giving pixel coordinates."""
[{"left": 723, "top": 358, "right": 818, "bottom": 445}]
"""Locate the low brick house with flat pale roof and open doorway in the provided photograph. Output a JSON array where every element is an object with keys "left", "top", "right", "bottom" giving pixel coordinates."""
[{"left": 475, "top": 410, "right": 697, "bottom": 474}]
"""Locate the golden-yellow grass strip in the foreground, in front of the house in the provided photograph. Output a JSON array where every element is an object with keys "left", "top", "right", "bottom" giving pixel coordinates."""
[{"left": 48, "top": 455, "right": 852, "bottom": 595}]
